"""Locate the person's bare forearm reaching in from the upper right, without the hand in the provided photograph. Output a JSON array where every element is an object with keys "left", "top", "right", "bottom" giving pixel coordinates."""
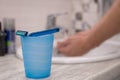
[{"left": 88, "top": 0, "right": 120, "bottom": 46}]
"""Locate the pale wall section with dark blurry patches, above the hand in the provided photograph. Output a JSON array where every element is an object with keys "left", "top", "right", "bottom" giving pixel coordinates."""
[{"left": 72, "top": 0, "right": 99, "bottom": 30}]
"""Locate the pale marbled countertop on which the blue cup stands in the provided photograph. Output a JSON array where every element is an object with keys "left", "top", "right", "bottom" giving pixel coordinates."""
[{"left": 0, "top": 54, "right": 120, "bottom": 80}]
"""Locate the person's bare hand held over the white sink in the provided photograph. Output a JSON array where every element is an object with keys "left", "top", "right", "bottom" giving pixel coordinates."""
[{"left": 57, "top": 31, "right": 93, "bottom": 56}]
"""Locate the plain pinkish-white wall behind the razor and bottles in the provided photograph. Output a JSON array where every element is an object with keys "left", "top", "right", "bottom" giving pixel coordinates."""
[{"left": 0, "top": 0, "right": 70, "bottom": 31}]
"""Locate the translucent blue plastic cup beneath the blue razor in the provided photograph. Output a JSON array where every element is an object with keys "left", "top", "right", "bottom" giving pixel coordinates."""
[{"left": 21, "top": 34, "right": 54, "bottom": 79}]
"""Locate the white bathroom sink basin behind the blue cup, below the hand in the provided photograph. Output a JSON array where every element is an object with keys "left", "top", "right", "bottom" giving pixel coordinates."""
[{"left": 17, "top": 39, "right": 120, "bottom": 64}]
